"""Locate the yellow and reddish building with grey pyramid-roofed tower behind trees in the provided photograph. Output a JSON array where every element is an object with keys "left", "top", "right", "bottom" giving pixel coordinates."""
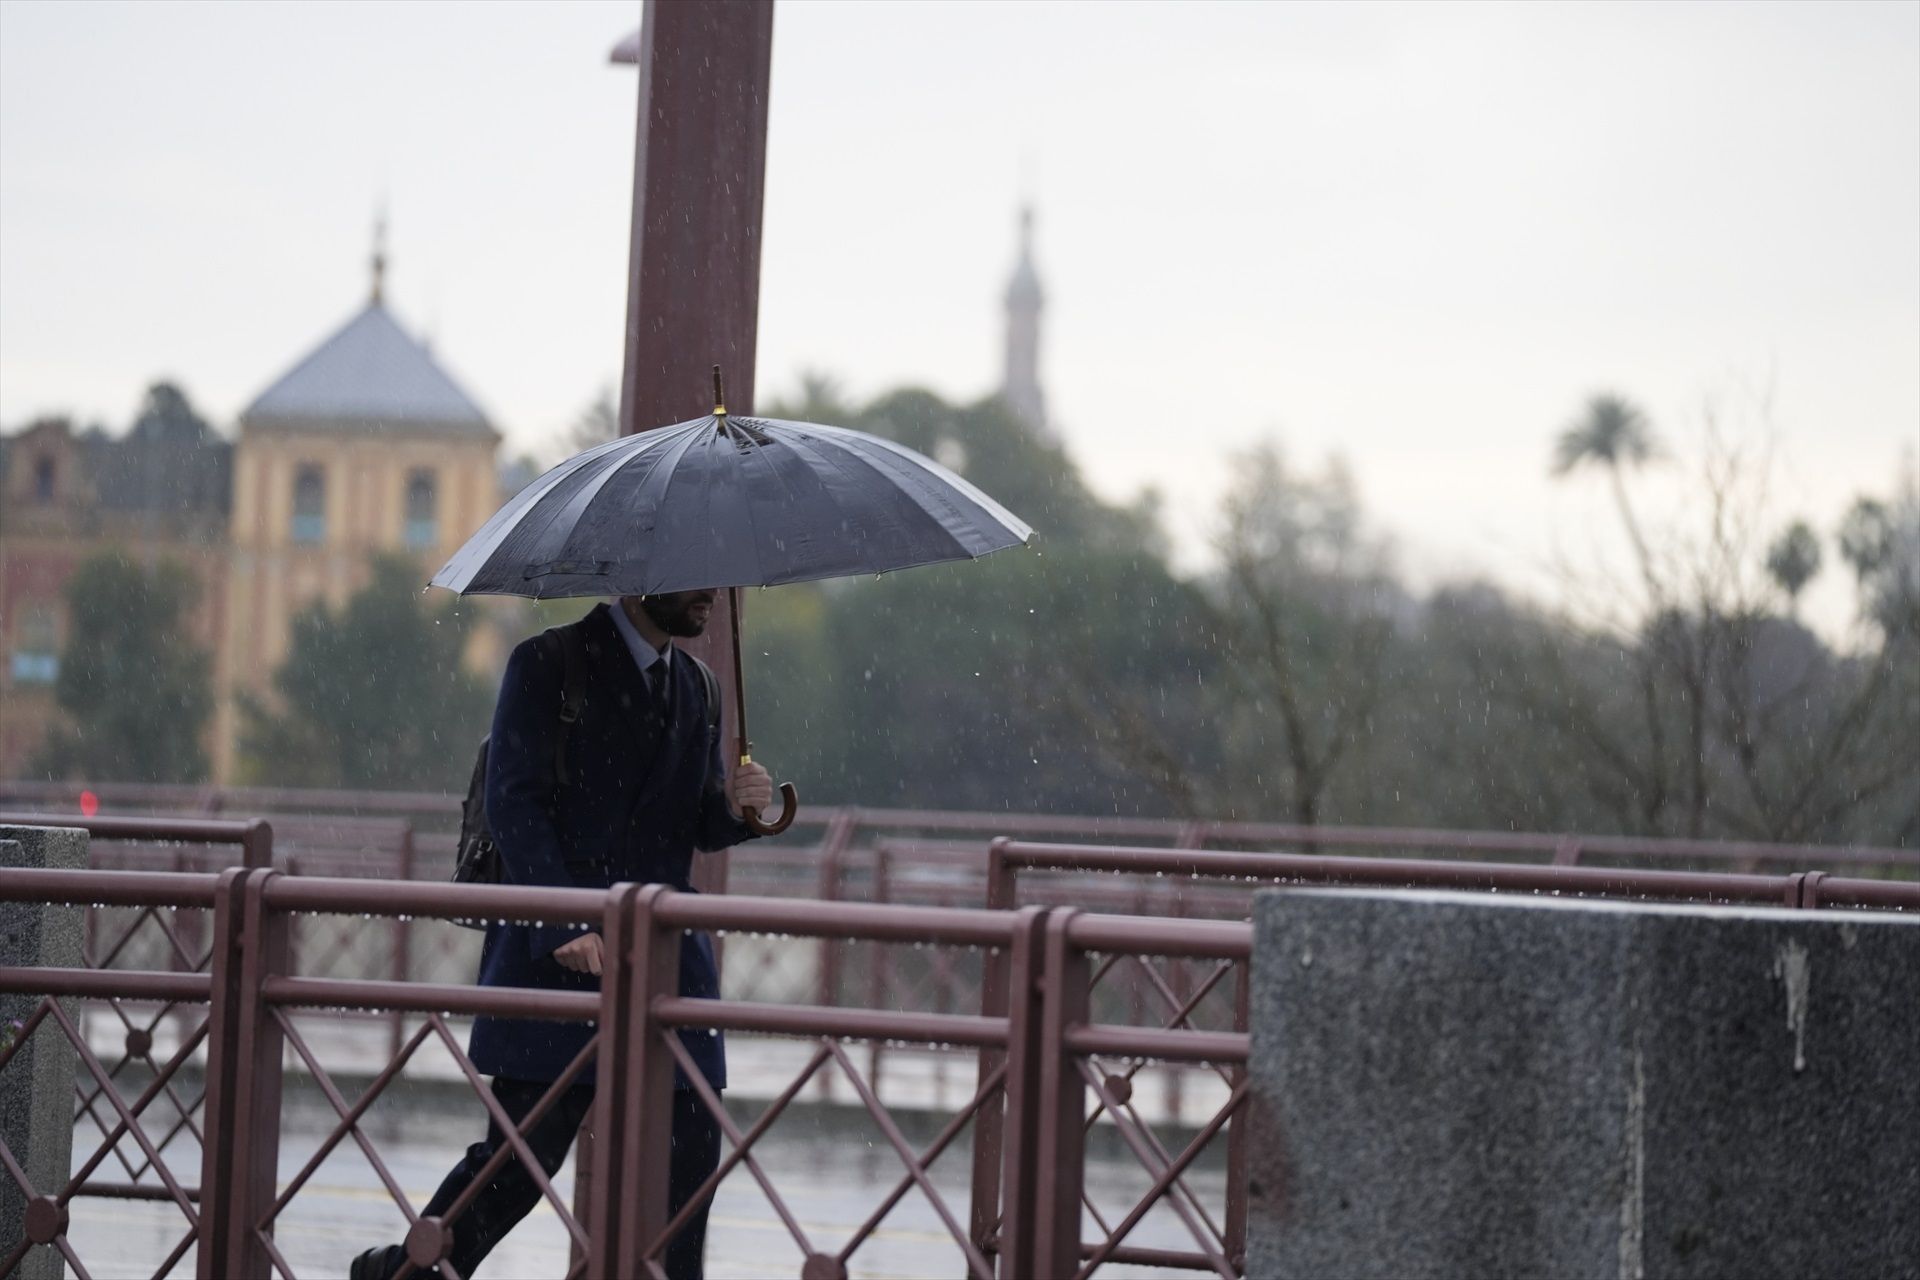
[{"left": 0, "top": 266, "right": 503, "bottom": 783}]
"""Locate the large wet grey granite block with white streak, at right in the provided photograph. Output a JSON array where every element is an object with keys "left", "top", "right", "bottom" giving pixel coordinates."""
[{"left": 1248, "top": 890, "right": 1920, "bottom": 1280}]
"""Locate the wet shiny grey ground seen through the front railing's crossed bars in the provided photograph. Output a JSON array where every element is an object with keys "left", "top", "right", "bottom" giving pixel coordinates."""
[{"left": 71, "top": 1036, "right": 1225, "bottom": 1280}]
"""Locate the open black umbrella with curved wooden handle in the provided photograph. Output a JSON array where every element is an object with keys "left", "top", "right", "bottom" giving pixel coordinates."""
[{"left": 434, "top": 367, "right": 1033, "bottom": 835}]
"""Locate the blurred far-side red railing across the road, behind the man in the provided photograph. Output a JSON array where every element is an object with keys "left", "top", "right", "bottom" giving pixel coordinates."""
[{"left": 22, "top": 809, "right": 1910, "bottom": 1169}]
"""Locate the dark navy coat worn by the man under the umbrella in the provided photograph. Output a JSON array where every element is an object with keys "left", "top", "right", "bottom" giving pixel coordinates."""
[{"left": 468, "top": 604, "right": 751, "bottom": 1088}]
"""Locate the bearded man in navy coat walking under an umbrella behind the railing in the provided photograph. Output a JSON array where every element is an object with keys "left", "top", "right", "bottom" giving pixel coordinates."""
[{"left": 349, "top": 589, "right": 774, "bottom": 1280}]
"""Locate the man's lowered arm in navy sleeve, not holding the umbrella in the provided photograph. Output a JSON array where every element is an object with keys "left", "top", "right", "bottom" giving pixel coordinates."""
[{"left": 486, "top": 637, "right": 588, "bottom": 958}]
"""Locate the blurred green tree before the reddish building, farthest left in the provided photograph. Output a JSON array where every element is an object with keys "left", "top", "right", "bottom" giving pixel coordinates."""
[{"left": 31, "top": 551, "right": 213, "bottom": 783}]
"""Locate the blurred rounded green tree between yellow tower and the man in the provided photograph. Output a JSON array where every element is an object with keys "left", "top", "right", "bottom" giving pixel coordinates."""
[{"left": 240, "top": 557, "right": 490, "bottom": 791}]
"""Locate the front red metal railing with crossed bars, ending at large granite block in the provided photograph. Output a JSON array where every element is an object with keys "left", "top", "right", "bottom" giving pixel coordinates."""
[{"left": 0, "top": 867, "right": 1248, "bottom": 1276}]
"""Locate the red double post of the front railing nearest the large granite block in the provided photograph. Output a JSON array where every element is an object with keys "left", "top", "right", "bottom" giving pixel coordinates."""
[{"left": 1010, "top": 908, "right": 1091, "bottom": 1276}]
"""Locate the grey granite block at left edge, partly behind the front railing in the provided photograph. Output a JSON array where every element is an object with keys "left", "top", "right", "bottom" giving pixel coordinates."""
[{"left": 0, "top": 827, "right": 86, "bottom": 1280}]
